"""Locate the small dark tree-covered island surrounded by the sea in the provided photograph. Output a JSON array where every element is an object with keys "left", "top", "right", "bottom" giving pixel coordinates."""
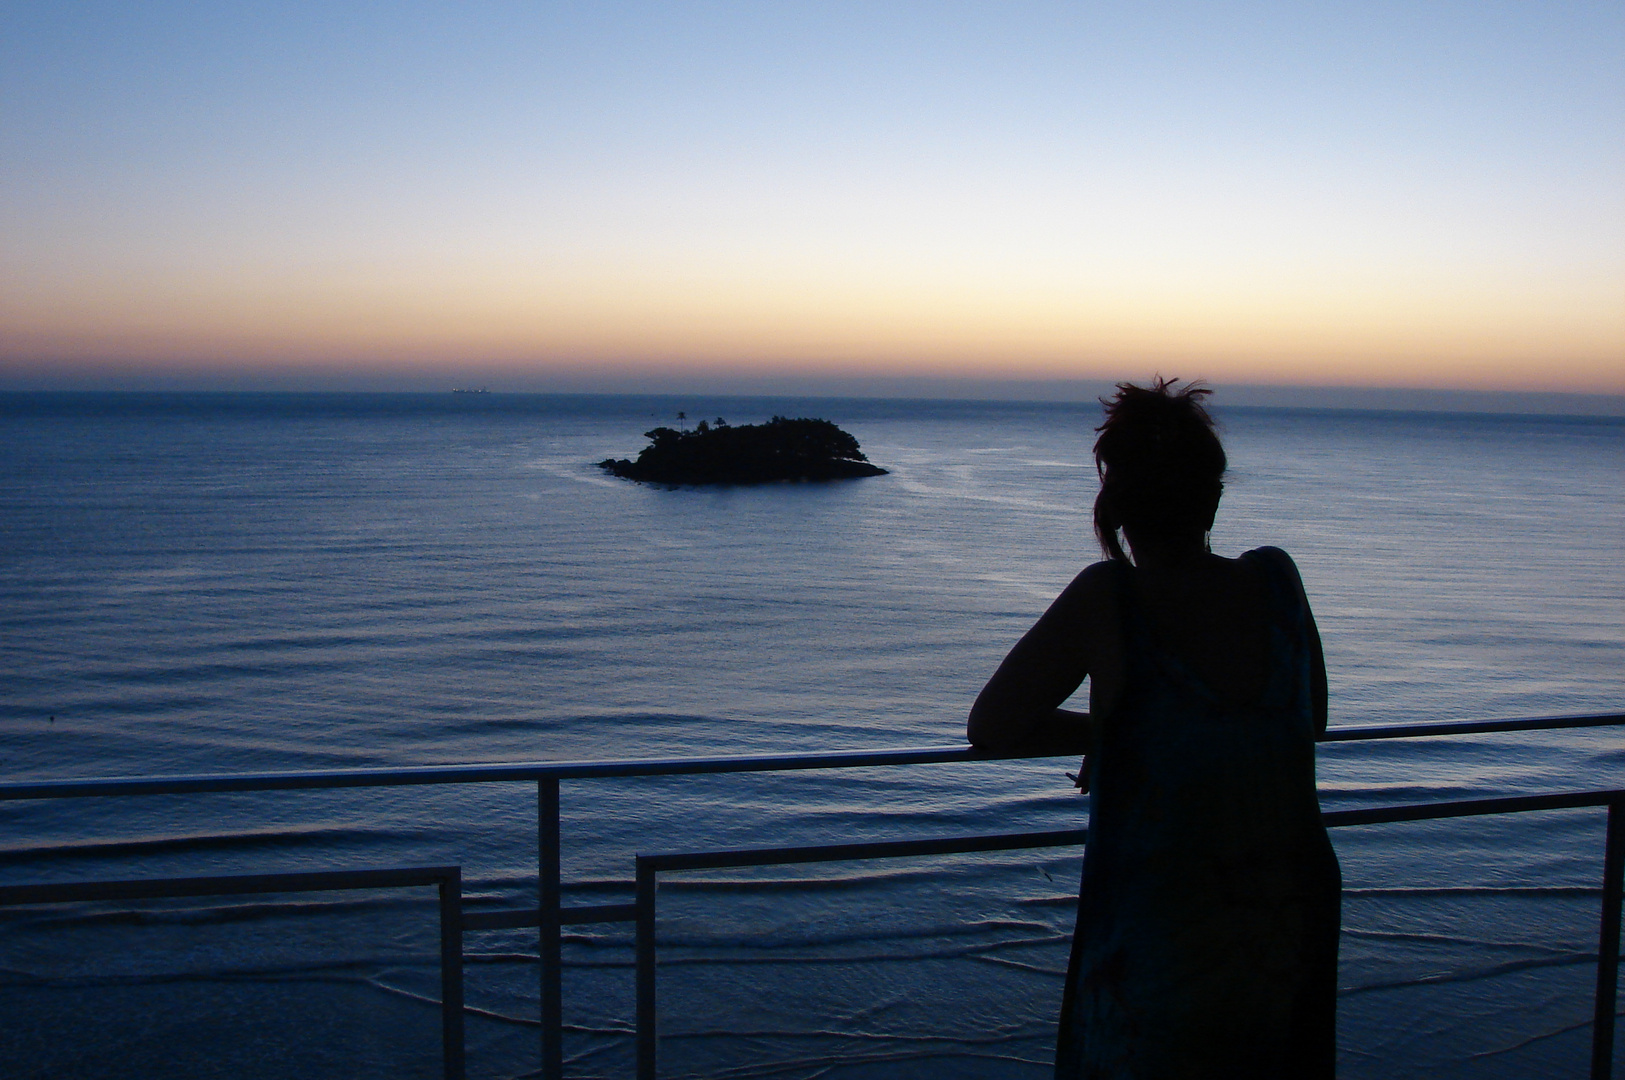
[{"left": 598, "top": 413, "right": 886, "bottom": 484}]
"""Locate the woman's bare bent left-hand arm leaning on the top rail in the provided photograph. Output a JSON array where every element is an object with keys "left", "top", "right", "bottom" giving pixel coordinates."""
[{"left": 965, "top": 564, "right": 1105, "bottom": 754}]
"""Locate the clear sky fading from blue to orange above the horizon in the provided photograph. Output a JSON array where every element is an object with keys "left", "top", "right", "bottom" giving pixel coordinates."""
[{"left": 0, "top": 0, "right": 1625, "bottom": 395}]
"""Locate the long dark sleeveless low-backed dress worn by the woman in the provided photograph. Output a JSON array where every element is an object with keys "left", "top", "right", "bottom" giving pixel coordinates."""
[{"left": 1055, "top": 547, "right": 1341, "bottom": 1080}]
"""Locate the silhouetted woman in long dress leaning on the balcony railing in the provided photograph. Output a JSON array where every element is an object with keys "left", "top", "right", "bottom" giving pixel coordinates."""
[{"left": 969, "top": 380, "right": 1341, "bottom": 1080}]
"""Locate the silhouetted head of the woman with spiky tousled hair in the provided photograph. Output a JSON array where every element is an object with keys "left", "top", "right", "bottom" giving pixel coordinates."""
[{"left": 1095, "top": 377, "right": 1225, "bottom": 562}]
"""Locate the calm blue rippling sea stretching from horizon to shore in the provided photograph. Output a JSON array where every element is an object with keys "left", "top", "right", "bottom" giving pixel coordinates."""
[{"left": 0, "top": 395, "right": 1625, "bottom": 1080}]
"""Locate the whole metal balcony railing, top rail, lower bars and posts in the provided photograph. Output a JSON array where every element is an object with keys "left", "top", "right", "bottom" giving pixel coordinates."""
[{"left": 0, "top": 713, "right": 1625, "bottom": 1080}]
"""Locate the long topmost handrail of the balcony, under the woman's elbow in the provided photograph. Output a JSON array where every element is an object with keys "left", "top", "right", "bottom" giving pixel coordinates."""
[{"left": 0, "top": 713, "right": 1625, "bottom": 799}]
